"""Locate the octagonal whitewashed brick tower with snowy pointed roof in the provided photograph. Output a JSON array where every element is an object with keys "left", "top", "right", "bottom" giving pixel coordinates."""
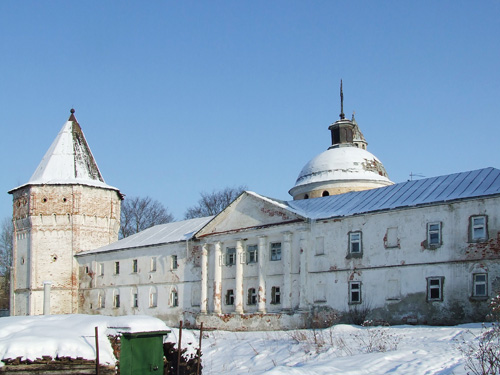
[{"left": 9, "top": 109, "right": 122, "bottom": 315}]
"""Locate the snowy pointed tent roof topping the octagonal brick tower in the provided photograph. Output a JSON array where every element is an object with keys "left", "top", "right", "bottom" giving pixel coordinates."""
[{"left": 10, "top": 109, "right": 118, "bottom": 190}]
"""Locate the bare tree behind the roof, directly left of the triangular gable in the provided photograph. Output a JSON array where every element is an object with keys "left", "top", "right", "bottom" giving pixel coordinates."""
[{"left": 184, "top": 186, "right": 247, "bottom": 219}]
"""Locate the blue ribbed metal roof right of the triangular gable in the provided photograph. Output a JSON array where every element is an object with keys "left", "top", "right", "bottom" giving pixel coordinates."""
[{"left": 286, "top": 168, "right": 500, "bottom": 219}]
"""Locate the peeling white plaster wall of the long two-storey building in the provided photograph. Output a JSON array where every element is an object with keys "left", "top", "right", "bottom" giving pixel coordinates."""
[{"left": 78, "top": 198, "right": 500, "bottom": 330}]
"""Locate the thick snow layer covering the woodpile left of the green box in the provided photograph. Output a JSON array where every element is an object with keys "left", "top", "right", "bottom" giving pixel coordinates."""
[{"left": 0, "top": 315, "right": 170, "bottom": 365}]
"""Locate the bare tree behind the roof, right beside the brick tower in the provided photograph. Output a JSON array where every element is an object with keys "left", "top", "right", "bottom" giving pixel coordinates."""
[{"left": 120, "top": 197, "right": 174, "bottom": 238}]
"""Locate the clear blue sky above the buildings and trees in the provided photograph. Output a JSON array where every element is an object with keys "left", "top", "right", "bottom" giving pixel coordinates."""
[{"left": 0, "top": 0, "right": 500, "bottom": 219}]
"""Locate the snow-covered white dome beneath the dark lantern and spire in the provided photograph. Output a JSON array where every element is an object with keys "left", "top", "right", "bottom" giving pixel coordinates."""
[{"left": 290, "top": 147, "right": 392, "bottom": 197}]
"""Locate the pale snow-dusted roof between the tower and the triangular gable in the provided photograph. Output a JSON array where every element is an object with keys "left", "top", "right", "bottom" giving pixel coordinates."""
[{"left": 78, "top": 216, "right": 213, "bottom": 255}]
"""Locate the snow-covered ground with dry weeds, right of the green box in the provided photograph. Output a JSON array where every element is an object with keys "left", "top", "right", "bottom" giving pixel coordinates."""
[{"left": 193, "top": 324, "right": 481, "bottom": 375}]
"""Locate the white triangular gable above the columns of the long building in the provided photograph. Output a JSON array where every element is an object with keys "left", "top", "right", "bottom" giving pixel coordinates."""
[{"left": 196, "top": 191, "right": 305, "bottom": 238}]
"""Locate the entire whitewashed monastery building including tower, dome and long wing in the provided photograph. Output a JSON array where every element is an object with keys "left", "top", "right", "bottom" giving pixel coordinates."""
[{"left": 9, "top": 93, "right": 500, "bottom": 330}]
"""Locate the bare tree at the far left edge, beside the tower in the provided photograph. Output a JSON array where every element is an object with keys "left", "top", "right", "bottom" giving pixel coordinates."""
[{"left": 0, "top": 217, "right": 14, "bottom": 309}]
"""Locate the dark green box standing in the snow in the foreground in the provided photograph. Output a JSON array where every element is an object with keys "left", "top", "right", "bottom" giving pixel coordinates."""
[{"left": 120, "top": 331, "right": 170, "bottom": 375}]
